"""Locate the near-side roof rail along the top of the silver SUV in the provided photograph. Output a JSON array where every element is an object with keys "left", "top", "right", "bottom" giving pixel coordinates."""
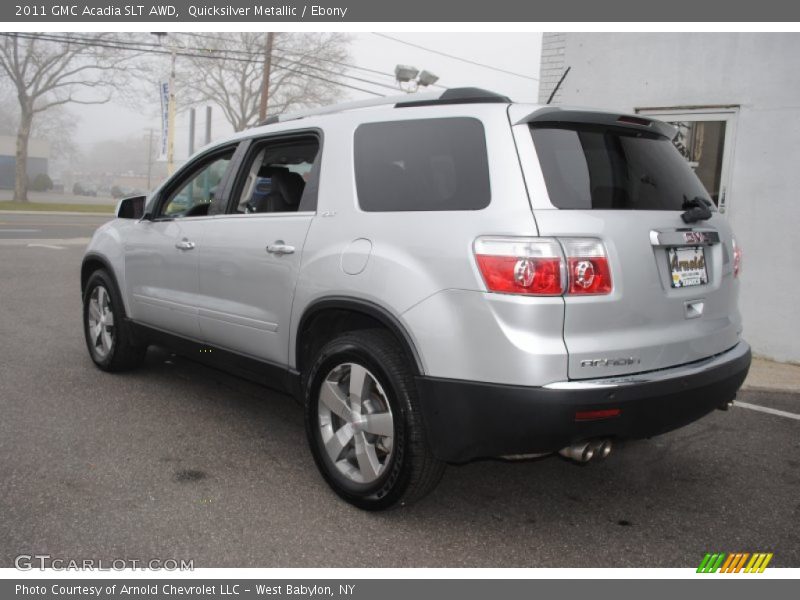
[{"left": 255, "top": 87, "right": 511, "bottom": 127}]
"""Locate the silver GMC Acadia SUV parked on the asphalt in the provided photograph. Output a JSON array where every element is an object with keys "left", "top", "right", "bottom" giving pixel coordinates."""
[{"left": 81, "top": 88, "right": 750, "bottom": 510}]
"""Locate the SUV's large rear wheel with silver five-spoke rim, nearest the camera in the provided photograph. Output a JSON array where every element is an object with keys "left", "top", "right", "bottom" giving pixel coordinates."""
[{"left": 305, "top": 330, "right": 444, "bottom": 510}]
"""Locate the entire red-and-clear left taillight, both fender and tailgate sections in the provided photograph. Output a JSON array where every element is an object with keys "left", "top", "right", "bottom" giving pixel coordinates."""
[{"left": 475, "top": 237, "right": 612, "bottom": 296}]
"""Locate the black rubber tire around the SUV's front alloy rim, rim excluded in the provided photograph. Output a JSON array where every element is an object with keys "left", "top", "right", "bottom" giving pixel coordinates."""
[{"left": 83, "top": 269, "right": 147, "bottom": 372}]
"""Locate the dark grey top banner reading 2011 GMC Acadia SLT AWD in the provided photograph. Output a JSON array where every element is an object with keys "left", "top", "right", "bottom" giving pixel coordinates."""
[{"left": 0, "top": 0, "right": 800, "bottom": 24}]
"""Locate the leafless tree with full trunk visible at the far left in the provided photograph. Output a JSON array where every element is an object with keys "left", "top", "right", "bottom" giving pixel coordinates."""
[{"left": 0, "top": 33, "right": 139, "bottom": 202}]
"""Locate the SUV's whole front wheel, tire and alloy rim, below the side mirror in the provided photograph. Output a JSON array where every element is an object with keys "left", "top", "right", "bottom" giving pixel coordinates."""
[{"left": 83, "top": 269, "right": 147, "bottom": 372}]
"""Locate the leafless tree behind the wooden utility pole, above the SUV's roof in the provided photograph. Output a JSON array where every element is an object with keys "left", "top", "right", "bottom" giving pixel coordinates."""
[{"left": 178, "top": 32, "right": 350, "bottom": 131}]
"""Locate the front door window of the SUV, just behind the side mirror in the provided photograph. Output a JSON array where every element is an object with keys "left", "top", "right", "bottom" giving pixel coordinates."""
[{"left": 161, "top": 149, "right": 233, "bottom": 217}]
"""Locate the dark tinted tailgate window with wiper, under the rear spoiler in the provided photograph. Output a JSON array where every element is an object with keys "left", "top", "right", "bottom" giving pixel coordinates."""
[{"left": 531, "top": 125, "right": 710, "bottom": 210}]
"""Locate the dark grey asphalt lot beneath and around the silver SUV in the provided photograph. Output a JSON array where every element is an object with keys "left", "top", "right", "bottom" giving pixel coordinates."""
[{"left": 0, "top": 215, "right": 800, "bottom": 567}]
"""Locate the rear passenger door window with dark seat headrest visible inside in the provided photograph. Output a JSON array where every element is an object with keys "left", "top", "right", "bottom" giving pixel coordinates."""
[{"left": 234, "top": 137, "right": 319, "bottom": 214}]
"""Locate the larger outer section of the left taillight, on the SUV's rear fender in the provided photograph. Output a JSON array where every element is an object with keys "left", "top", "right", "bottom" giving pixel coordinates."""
[{"left": 475, "top": 238, "right": 564, "bottom": 296}]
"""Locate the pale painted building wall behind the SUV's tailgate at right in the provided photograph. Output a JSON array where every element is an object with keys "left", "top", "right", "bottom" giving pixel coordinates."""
[{"left": 540, "top": 33, "right": 800, "bottom": 362}]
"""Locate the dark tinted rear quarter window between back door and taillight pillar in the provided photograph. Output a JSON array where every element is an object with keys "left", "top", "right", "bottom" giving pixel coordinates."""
[{"left": 355, "top": 118, "right": 490, "bottom": 212}]
